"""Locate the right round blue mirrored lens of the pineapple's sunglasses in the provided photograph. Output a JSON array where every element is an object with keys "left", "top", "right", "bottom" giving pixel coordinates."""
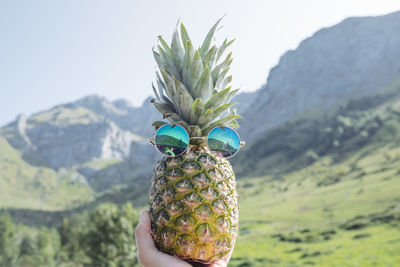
[{"left": 207, "top": 126, "right": 240, "bottom": 158}]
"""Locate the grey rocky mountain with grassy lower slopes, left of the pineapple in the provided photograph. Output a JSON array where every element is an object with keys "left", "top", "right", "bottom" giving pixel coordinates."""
[{"left": 0, "top": 96, "right": 159, "bottom": 210}]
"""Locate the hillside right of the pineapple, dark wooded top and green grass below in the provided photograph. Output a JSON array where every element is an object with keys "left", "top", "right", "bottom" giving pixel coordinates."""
[{"left": 231, "top": 91, "right": 400, "bottom": 266}]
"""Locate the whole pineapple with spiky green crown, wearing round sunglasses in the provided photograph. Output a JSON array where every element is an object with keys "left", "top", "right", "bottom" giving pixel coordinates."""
[{"left": 150, "top": 19, "right": 240, "bottom": 264}]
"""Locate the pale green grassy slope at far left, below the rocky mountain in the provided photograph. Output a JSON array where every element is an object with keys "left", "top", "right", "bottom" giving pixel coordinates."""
[{"left": 0, "top": 136, "right": 93, "bottom": 210}]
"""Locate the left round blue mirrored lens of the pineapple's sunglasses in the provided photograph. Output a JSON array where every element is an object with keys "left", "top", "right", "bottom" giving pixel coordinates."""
[{"left": 155, "top": 124, "right": 189, "bottom": 157}]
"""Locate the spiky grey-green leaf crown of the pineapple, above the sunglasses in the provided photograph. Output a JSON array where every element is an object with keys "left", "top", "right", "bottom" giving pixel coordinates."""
[{"left": 151, "top": 18, "right": 241, "bottom": 136}]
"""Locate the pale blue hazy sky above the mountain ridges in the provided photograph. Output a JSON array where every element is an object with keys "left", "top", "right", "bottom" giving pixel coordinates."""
[{"left": 0, "top": 0, "right": 400, "bottom": 126}]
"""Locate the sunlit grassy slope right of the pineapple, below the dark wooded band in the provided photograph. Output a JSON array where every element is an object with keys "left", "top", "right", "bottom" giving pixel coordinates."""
[{"left": 230, "top": 142, "right": 400, "bottom": 266}]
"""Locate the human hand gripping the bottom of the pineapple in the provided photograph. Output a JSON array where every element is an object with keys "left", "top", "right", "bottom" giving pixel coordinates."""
[{"left": 135, "top": 210, "right": 231, "bottom": 267}]
